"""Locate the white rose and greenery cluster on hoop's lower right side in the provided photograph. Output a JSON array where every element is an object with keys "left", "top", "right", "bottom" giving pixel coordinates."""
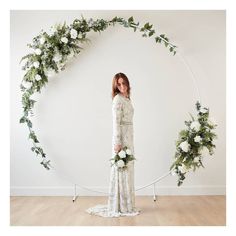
[{"left": 170, "top": 102, "right": 217, "bottom": 186}]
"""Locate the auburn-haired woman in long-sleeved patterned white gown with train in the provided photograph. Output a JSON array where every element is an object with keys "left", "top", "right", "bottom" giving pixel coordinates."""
[{"left": 86, "top": 73, "right": 140, "bottom": 217}]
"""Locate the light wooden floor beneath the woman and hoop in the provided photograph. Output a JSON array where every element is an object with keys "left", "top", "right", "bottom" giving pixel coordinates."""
[{"left": 10, "top": 196, "right": 226, "bottom": 226}]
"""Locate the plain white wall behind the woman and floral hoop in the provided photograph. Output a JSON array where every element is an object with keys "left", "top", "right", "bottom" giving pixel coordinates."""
[{"left": 10, "top": 10, "right": 226, "bottom": 195}]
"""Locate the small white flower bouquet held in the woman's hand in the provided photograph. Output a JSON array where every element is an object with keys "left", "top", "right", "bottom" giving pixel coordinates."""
[{"left": 110, "top": 146, "right": 135, "bottom": 170}]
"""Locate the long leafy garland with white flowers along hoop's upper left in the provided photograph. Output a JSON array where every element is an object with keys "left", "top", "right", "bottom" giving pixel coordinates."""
[{"left": 20, "top": 15, "right": 177, "bottom": 170}]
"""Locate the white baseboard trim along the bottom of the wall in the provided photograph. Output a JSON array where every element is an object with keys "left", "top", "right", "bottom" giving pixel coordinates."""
[{"left": 10, "top": 185, "right": 226, "bottom": 196}]
